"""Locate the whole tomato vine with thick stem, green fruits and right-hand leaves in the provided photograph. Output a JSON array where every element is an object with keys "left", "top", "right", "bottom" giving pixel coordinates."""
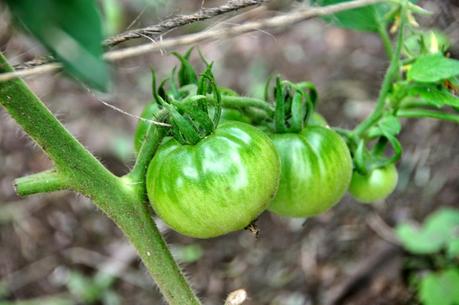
[{"left": 0, "top": 0, "right": 459, "bottom": 304}]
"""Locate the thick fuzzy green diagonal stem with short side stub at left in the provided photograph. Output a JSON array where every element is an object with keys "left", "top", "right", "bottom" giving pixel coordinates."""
[{"left": 0, "top": 53, "right": 201, "bottom": 305}]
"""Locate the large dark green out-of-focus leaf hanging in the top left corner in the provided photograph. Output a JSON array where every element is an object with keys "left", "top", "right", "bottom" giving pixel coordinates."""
[{"left": 6, "top": 0, "right": 109, "bottom": 90}]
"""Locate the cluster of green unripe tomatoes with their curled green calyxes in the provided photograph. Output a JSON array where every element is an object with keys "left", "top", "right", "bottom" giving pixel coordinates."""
[{"left": 135, "top": 57, "right": 397, "bottom": 238}]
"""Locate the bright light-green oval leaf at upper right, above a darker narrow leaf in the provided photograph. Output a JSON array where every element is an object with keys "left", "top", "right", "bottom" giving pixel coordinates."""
[{"left": 408, "top": 54, "right": 459, "bottom": 83}]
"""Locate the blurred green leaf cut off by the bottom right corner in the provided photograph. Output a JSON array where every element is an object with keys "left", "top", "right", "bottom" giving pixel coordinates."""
[{"left": 419, "top": 268, "right": 459, "bottom": 305}]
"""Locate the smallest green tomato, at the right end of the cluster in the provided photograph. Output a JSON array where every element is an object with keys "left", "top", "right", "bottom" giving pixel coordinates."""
[{"left": 349, "top": 164, "right": 398, "bottom": 203}]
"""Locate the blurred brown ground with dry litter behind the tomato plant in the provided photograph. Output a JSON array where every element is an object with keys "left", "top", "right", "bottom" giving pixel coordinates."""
[{"left": 0, "top": 0, "right": 459, "bottom": 305}]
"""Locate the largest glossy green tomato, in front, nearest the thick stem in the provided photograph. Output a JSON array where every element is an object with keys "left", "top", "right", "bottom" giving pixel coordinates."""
[{"left": 146, "top": 121, "right": 280, "bottom": 238}]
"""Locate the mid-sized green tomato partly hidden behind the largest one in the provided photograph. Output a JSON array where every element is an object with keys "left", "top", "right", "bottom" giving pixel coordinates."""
[{"left": 269, "top": 126, "right": 352, "bottom": 217}]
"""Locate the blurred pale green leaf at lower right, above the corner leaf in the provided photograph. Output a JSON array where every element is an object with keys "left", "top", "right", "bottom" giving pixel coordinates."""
[{"left": 395, "top": 209, "right": 459, "bottom": 254}]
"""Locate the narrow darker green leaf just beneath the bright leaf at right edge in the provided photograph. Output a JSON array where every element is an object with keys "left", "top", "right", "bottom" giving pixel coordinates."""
[{"left": 408, "top": 84, "right": 459, "bottom": 108}]
